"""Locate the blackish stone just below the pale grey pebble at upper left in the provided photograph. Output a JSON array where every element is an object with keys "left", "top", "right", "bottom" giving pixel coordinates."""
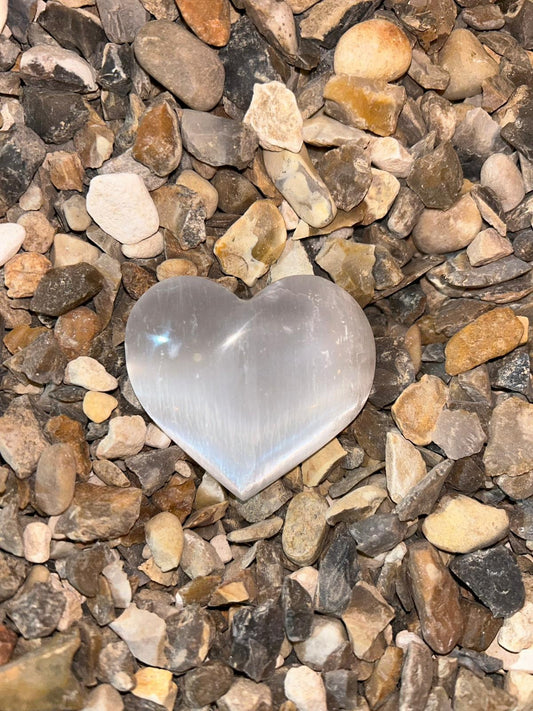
[{"left": 22, "top": 86, "right": 89, "bottom": 143}]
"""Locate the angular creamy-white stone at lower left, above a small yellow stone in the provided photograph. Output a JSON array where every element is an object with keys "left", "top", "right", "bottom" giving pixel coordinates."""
[{"left": 109, "top": 603, "right": 166, "bottom": 666}]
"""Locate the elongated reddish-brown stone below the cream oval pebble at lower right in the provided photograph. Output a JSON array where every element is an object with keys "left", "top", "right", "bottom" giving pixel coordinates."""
[{"left": 408, "top": 541, "right": 463, "bottom": 654}]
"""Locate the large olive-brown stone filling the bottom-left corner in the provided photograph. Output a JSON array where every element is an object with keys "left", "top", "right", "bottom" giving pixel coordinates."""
[{"left": 0, "top": 633, "right": 84, "bottom": 711}]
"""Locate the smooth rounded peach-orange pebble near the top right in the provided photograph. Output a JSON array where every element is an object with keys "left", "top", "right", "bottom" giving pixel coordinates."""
[{"left": 334, "top": 19, "right": 411, "bottom": 81}]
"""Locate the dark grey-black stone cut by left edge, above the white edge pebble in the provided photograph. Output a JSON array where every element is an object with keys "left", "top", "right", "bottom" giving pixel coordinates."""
[{"left": 0, "top": 124, "right": 46, "bottom": 216}]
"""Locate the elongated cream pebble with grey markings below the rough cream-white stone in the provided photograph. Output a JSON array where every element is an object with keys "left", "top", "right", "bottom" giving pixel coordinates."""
[{"left": 263, "top": 148, "right": 337, "bottom": 227}]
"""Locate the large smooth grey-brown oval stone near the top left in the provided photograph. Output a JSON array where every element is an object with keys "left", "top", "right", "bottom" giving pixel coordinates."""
[{"left": 133, "top": 20, "right": 224, "bottom": 111}]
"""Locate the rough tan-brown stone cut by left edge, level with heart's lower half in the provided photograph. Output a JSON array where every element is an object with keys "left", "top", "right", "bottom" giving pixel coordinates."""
[{"left": 0, "top": 395, "right": 48, "bottom": 479}]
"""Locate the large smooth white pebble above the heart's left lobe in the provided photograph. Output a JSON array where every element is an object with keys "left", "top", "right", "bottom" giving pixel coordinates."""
[{"left": 87, "top": 173, "right": 159, "bottom": 244}]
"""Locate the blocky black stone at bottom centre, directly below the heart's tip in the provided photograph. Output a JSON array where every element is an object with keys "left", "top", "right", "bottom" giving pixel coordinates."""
[{"left": 230, "top": 600, "right": 284, "bottom": 681}]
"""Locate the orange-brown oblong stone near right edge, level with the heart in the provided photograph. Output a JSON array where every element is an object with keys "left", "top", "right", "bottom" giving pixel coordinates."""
[{"left": 445, "top": 307, "right": 523, "bottom": 382}]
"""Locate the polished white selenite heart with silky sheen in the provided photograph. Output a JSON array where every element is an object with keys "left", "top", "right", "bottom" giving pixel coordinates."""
[{"left": 126, "top": 276, "right": 375, "bottom": 499}]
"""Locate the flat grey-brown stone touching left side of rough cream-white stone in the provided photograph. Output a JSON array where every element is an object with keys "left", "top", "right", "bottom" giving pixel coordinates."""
[{"left": 181, "top": 109, "right": 258, "bottom": 170}]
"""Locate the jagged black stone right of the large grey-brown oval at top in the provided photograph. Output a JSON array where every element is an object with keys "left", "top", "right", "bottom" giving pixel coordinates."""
[{"left": 218, "top": 17, "right": 289, "bottom": 111}]
